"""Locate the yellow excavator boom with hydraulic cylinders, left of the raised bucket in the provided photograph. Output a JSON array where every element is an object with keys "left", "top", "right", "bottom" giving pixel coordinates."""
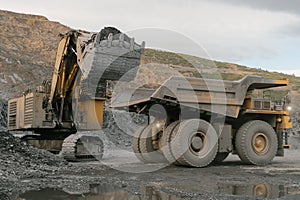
[{"left": 47, "top": 31, "right": 79, "bottom": 124}]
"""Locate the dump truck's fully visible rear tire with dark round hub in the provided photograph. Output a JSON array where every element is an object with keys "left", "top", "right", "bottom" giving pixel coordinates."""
[{"left": 170, "top": 119, "right": 218, "bottom": 167}]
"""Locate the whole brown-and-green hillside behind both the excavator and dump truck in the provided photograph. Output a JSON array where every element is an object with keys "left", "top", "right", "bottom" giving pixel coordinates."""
[{"left": 0, "top": 10, "right": 300, "bottom": 106}]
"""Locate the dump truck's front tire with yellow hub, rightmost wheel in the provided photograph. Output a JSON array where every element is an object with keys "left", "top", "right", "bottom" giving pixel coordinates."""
[{"left": 235, "top": 120, "right": 278, "bottom": 165}]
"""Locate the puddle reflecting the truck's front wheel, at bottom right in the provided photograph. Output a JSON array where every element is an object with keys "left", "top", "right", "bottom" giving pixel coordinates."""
[{"left": 218, "top": 183, "right": 300, "bottom": 199}]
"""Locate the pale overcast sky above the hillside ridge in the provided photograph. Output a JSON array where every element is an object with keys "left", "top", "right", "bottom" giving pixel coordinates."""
[{"left": 0, "top": 0, "right": 300, "bottom": 76}]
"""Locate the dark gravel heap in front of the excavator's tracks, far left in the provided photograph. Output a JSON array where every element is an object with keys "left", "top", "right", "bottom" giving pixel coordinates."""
[{"left": 0, "top": 132, "right": 67, "bottom": 179}]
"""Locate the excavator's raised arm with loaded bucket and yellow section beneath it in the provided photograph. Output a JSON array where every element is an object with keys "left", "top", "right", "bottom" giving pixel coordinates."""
[{"left": 47, "top": 27, "right": 144, "bottom": 130}]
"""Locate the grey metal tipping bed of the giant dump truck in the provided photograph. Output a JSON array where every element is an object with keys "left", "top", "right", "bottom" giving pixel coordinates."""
[{"left": 111, "top": 76, "right": 288, "bottom": 118}]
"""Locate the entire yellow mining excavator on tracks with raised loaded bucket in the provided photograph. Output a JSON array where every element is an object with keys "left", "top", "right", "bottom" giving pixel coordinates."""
[{"left": 8, "top": 27, "right": 145, "bottom": 161}]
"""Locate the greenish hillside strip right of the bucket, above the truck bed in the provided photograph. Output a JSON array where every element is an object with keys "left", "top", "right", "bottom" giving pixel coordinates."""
[{"left": 144, "top": 49, "right": 300, "bottom": 90}]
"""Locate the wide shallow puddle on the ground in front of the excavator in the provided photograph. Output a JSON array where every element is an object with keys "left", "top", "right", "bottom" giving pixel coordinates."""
[{"left": 19, "top": 185, "right": 178, "bottom": 200}]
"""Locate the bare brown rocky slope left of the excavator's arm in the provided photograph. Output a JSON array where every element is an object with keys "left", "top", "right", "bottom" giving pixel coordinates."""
[{"left": 0, "top": 10, "right": 69, "bottom": 98}]
